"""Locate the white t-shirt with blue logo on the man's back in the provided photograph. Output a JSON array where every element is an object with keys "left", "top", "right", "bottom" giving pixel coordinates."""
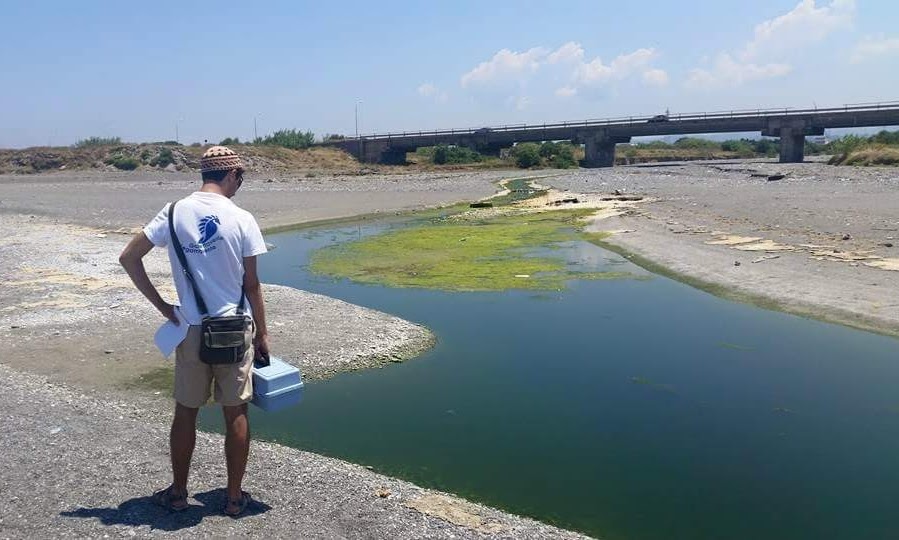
[{"left": 144, "top": 191, "right": 268, "bottom": 325}]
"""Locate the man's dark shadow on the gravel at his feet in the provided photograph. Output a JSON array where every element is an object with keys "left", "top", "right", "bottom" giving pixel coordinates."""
[{"left": 59, "top": 489, "right": 272, "bottom": 531}]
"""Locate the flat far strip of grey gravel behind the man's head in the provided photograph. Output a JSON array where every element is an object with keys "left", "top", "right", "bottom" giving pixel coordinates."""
[{"left": 0, "top": 171, "right": 521, "bottom": 231}]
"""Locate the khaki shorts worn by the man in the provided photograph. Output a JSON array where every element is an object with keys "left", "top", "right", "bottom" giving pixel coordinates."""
[{"left": 175, "top": 326, "right": 253, "bottom": 409}]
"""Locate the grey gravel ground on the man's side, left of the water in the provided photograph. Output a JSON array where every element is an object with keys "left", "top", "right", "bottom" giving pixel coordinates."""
[{"left": 0, "top": 173, "right": 592, "bottom": 538}]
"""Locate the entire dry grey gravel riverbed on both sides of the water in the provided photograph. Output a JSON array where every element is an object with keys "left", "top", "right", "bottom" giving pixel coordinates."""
[{"left": 0, "top": 161, "right": 899, "bottom": 538}]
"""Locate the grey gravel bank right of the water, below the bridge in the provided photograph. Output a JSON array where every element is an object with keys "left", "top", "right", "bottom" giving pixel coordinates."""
[{"left": 541, "top": 161, "right": 899, "bottom": 335}]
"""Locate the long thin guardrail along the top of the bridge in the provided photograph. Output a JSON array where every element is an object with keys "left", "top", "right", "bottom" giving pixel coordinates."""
[{"left": 360, "top": 101, "right": 899, "bottom": 141}]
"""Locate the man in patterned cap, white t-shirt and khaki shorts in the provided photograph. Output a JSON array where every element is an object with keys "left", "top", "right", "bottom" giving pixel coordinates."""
[{"left": 119, "top": 146, "right": 268, "bottom": 517}]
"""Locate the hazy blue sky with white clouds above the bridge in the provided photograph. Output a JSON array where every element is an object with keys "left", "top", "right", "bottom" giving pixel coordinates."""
[{"left": 0, "top": 0, "right": 899, "bottom": 148}]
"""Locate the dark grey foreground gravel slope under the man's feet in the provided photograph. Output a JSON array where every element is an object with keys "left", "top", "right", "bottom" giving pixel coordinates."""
[{"left": 0, "top": 366, "right": 583, "bottom": 539}]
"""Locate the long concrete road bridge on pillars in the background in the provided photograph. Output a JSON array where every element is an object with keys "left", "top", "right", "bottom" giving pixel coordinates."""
[{"left": 322, "top": 101, "right": 899, "bottom": 167}]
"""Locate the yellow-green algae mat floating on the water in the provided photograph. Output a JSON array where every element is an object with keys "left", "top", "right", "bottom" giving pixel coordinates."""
[{"left": 310, "top": 207, "right": 631, "bottom": 291}]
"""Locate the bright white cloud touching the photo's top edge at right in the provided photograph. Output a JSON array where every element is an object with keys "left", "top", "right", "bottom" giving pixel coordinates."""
[{"left": 741, "top": 0, "right": 855, "bottom": 61}]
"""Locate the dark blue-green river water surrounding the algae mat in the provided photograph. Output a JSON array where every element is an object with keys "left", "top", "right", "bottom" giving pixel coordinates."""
[{"left": 201, "top": 216, "right": 899, "bottom": 539}]
